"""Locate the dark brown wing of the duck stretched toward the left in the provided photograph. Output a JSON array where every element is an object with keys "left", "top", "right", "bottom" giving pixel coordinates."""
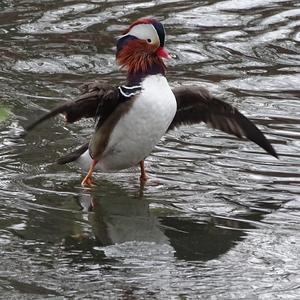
[{"left": 22, "top": 82, "right": 120, "bottom": 136}]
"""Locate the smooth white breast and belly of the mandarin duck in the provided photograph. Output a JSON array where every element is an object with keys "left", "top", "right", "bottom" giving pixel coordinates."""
[{"left": 85, "top": 75, "right": 177, "bottom": 171}]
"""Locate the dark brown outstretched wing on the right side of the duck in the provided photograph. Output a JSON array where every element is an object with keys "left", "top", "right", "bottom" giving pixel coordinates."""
[{"left": 168, "top": 86, "right": 278, "bottom": 158}]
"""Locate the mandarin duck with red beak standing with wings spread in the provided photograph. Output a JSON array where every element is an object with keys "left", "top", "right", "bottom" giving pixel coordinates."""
[{"left": 23, "top": 17, "right": 278, "bottom": 187}]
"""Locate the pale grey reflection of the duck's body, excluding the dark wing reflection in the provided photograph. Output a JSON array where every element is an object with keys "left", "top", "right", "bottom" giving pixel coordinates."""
[{"left": 80, "top": 186, "right": 168, "bottom": 246}]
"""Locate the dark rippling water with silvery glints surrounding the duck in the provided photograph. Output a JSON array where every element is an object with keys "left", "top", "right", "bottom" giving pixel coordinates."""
[{"left": 0, "top": 0, "right": 300, "bottom": 299}]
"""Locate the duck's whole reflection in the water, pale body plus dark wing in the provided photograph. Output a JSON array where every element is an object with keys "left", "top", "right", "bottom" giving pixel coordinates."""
[{"left": 76, "top": 180, "right": 251, "bottom": 261}]
